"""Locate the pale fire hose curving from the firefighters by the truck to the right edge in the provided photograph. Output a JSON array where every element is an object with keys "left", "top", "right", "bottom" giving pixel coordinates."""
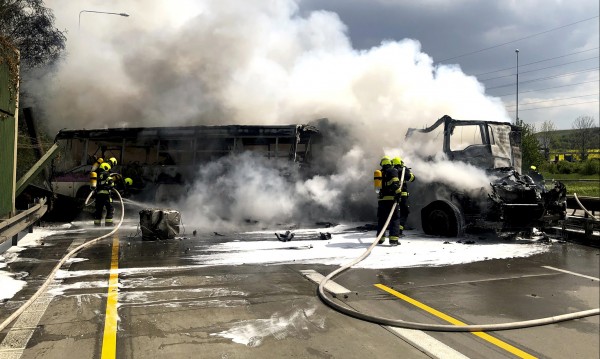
[{"left": 317, "top": 203, "right": 600, "bottom": 332}]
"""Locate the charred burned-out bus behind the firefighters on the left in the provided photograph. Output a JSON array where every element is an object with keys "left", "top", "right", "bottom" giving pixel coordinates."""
[{"left": 50, "top": 125, "right": 319, "bottom": 210}]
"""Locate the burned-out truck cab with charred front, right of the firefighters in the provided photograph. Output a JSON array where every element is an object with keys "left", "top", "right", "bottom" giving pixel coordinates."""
[{"left": 405, "top": 115, "right": 566, "bottom": 237}]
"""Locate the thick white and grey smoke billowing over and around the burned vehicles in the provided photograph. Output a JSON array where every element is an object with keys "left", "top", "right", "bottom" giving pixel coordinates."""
[{"left": 31, "top": 0, "right": 509, "bottom": 231}]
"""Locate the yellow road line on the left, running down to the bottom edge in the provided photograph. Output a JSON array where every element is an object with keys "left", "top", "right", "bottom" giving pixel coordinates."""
[{"left": 102, "top": 234, "right": 119, "bottom": 359}]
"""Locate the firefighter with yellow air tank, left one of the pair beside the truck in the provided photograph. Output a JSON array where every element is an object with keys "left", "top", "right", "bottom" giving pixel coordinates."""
[{"left": 377, "top": 156, "right": 400, "bottom": 246}]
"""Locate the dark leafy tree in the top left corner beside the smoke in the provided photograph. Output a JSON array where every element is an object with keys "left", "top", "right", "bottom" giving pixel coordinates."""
[{"left": 0, "top": 0, "right": 66, "bottom": 69}]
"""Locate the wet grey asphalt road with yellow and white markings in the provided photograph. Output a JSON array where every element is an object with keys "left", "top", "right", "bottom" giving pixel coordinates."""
[{"left": 0, "top": 219, "right": 600, "bottom": 358}]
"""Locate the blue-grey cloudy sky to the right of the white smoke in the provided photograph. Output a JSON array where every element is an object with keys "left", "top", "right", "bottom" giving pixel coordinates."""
[{"left": 301, "top": 0, "right": 600, "bottom": 129}]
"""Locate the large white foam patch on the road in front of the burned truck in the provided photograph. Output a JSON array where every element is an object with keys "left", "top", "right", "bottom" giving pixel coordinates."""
[{"left": 194, "top": 226, "right": 550, "bottom": 269}]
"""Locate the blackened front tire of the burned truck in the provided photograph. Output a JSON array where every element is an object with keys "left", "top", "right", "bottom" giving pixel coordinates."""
[{"left": 421, "top": 201, "right": 465, "bottom": 237}]
